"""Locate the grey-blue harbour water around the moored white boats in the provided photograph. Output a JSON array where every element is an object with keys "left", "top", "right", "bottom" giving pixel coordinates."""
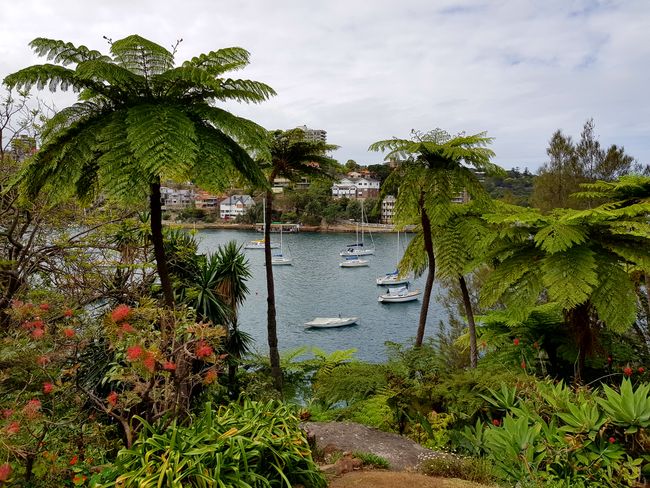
[{"left": 196, "top": 229, "right": 444, "bottom": 362}]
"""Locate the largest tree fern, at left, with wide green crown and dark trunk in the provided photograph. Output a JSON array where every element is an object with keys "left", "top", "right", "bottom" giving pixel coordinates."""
[{"left": 4, "top": 35, "right": 275, "bottom": 307}]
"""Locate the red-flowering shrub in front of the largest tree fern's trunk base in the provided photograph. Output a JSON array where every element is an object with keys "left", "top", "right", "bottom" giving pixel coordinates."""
[{"left": 81, "top": 304, "right": 225, "bottom": 446}]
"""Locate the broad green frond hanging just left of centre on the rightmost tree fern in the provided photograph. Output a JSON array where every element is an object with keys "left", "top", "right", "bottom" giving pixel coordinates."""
[{"left": 542, "top": 247, "right": 598, "bottom": 310}]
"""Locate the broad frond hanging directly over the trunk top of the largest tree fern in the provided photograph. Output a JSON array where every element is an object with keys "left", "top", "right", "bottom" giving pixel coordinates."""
[{"left": 126, "top": 104, "right": 198, "bottom": 182}]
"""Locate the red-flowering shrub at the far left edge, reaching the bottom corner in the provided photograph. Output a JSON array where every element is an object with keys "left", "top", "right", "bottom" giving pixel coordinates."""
[{"left": 0, "top": 297, "right": 114, "bottom": 486}]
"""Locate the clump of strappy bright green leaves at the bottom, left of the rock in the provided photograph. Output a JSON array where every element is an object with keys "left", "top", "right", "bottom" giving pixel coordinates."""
[{"left": 95, "top": 401, "right": 327, "bottom": 488}]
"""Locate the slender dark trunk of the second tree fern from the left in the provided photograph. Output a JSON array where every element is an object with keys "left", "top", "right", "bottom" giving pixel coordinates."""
[{"left": 264, "top": 190, "right": 282, "bottom": 393}]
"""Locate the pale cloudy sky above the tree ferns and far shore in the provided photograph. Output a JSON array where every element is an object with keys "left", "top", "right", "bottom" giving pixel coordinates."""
[{"left": 0, "top": 0, "right": 650, "bottom": 171}]
